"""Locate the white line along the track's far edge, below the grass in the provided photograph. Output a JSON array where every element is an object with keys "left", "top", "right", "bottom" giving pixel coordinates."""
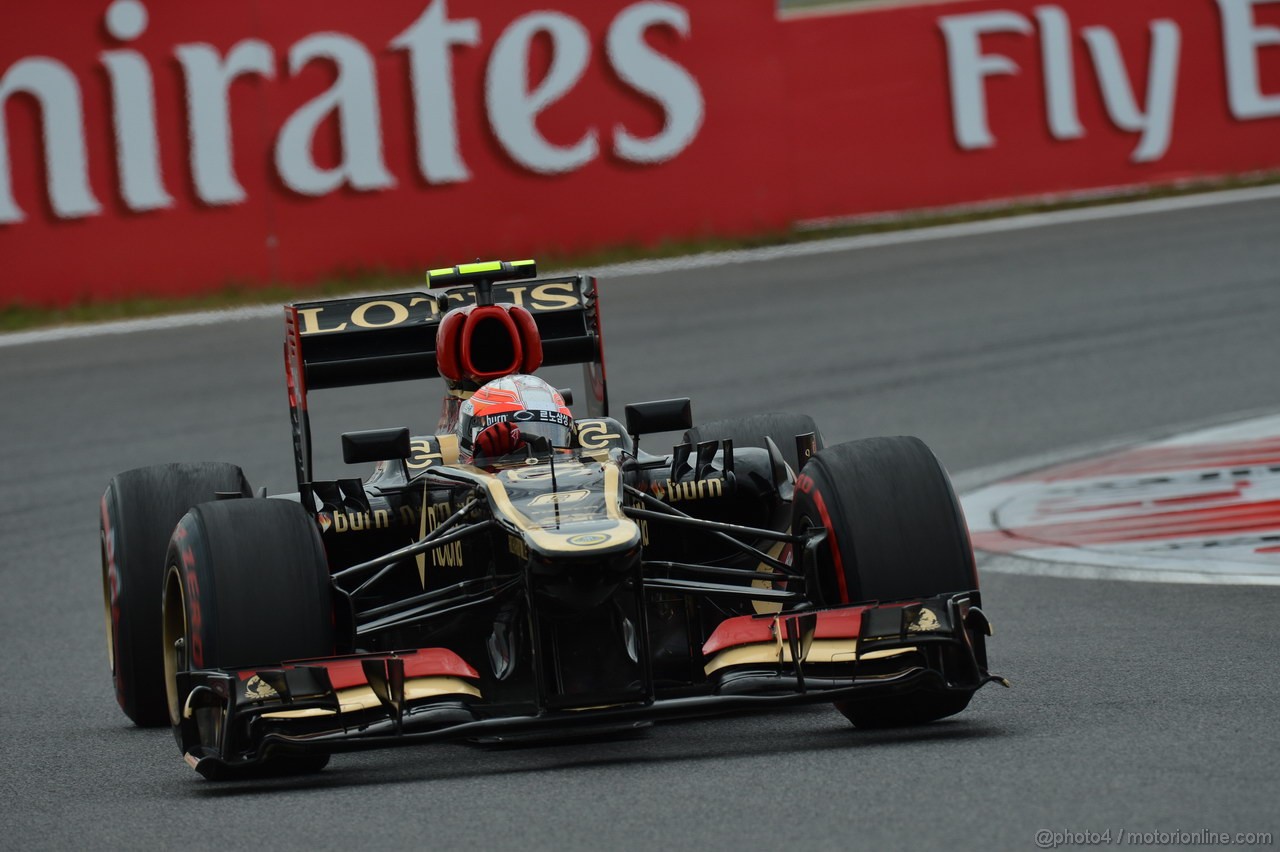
[{"left": 0, "top": 185, "right": 1280, "bottom": 348}]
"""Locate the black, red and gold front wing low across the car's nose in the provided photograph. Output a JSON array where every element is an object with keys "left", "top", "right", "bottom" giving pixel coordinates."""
[{"left": 178, "top": 592, "right": 1002, "bottom": 778}]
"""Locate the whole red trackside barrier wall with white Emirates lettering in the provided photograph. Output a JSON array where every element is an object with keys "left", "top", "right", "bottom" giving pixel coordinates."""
[{"left": 0, "top": 0, "right": 1280, "bottom": 304}]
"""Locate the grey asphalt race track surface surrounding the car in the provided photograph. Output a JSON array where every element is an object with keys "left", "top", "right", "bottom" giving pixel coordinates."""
[{"left": 0, "top": 195, "right": 1280, "bottom": 849}]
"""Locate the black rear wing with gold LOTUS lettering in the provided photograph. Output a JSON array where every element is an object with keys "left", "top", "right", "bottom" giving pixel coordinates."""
[{"left": 284, "top": 272, "right": 609, "bottom": 491}]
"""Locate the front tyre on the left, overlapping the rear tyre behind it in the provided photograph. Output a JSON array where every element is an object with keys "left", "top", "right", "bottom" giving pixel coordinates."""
[{"left": 161, "top": 499, "right": 334, "bottom": 777}]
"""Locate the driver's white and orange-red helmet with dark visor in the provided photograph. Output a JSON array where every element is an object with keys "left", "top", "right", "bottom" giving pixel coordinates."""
[{"left": 457, "top": 374, "right": 573, "bottom": 462}]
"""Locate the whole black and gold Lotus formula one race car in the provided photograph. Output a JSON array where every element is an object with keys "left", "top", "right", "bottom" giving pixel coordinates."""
[{"left": 102, "top": 261, "right": 998, "bottom": 778}]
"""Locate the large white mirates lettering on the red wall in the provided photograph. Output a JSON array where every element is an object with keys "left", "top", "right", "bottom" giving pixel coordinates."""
[{"left": 0, "top": 0, "right": 704, "bottom": 225}]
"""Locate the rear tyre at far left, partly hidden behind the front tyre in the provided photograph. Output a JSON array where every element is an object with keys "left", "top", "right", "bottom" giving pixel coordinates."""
[{"left": 100, "top": 462, "right": 250, "bottom": 727}]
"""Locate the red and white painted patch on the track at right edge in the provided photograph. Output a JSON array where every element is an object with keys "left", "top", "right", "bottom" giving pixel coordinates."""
[{"left": 964, "top": 416, "right": 1280, "bottom": 585}]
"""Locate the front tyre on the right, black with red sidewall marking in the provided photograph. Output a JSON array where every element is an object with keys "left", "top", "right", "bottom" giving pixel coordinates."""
[{"left": 792, "top": 438, "right": 978, "bottom": 728}]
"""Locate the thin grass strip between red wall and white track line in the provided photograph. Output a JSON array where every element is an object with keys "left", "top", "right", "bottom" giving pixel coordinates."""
[{"left": 0, "top": 173, "right": 1280, "bottom": 331}]
